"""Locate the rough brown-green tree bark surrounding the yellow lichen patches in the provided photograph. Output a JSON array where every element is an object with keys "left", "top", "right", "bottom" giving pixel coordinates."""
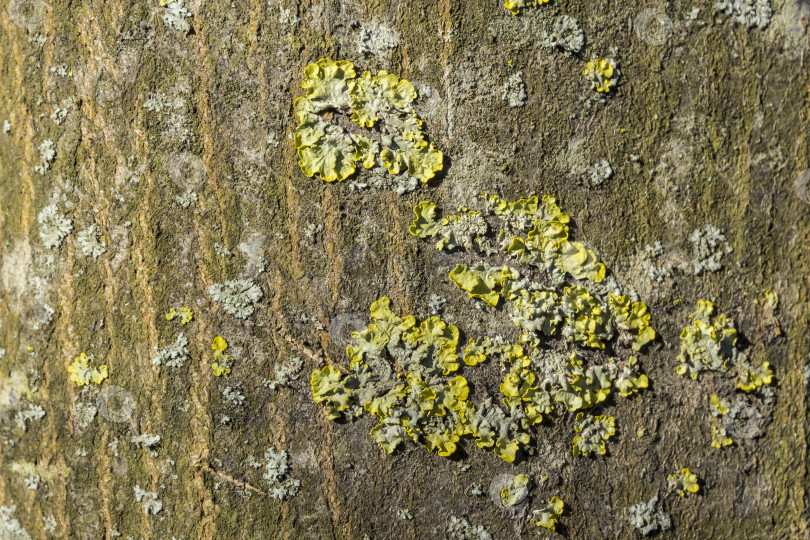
[{"left": 0, "top": 0, "right": 810, "bottom": 539}]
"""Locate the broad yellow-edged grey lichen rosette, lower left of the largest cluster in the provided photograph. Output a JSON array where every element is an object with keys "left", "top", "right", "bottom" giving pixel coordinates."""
[{"left": 312, "top": 297, "right": 550, "bottom": 462}]
